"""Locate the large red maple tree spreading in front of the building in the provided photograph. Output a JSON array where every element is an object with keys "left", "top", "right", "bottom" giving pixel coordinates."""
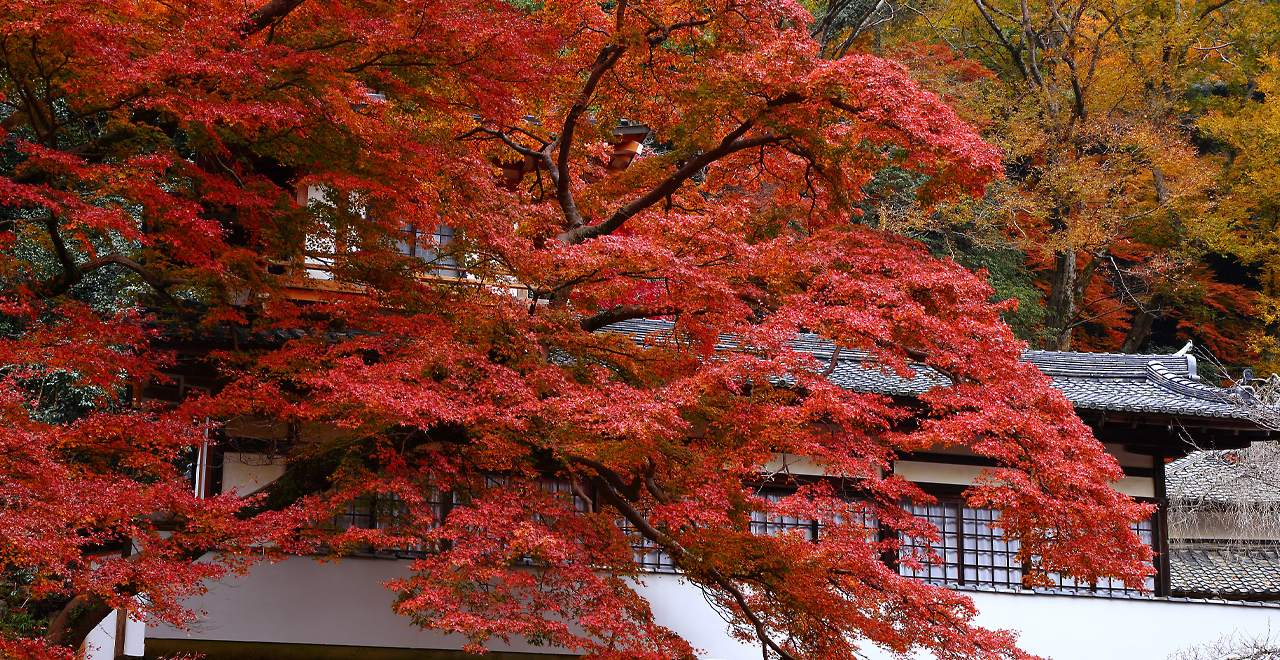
[{"left": 0, "top": 0, "right": 1149, "bottom": 659}]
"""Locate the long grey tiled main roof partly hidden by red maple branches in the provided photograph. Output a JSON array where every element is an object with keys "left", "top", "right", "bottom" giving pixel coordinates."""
[{"left": 605, "top": 320, "right": 1249, "bottom": 420}]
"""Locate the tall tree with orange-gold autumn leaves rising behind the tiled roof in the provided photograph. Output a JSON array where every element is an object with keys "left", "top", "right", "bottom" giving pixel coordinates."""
[{"left": 839, "top": 0, "right": 1274, "bottom": 359}]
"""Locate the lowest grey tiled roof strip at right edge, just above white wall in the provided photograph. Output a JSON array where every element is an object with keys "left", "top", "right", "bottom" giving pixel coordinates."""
[{"left": 1169, "top": 544, "right": 1280, "bottom": 599}]
